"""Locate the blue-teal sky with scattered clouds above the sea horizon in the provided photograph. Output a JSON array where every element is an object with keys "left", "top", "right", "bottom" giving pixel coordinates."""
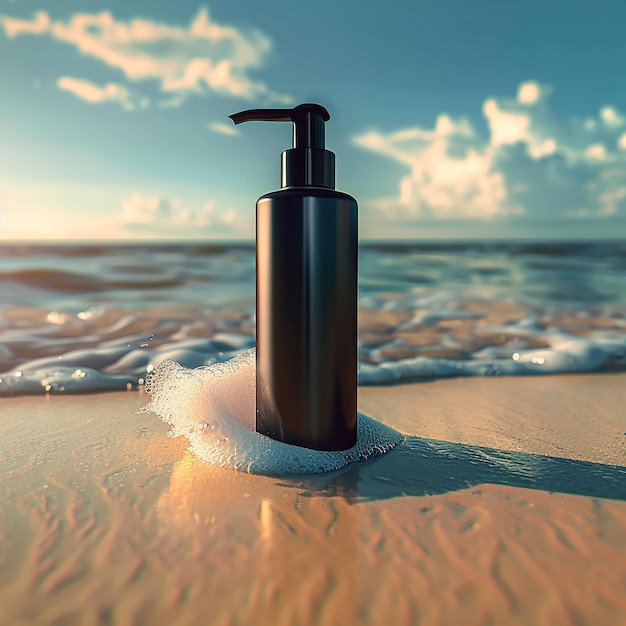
[{"left": 0, "top": 0, "right": 626, "bottom": 241}]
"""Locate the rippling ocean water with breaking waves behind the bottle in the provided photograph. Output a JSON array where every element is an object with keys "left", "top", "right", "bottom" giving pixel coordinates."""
[{"left": 0, "top": 242, "right": 626, "bottom": 396}]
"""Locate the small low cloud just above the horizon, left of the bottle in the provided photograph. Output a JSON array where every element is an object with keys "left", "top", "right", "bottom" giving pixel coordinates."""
[{"left": 120, "top": 192, "right": 247, "bottom": 235}]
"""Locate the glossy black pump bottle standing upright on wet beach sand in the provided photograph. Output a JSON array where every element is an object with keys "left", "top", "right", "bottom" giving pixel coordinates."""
[{"left": 230, "top": 104, "right": 358, "bottom": 450}]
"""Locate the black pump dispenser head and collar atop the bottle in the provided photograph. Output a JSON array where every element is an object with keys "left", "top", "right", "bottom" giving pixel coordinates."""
[{"left": 229, "top": 103, "right": 335, "bottom": 189}]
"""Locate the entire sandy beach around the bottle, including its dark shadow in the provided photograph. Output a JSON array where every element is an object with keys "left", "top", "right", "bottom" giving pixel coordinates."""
[{"left": 0, "top": 374, "right": 626, "bottom": 626}]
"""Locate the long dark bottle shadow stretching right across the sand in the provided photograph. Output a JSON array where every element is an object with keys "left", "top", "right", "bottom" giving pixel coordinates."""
[{"left": 283, "top": 437, "right": 626, "bottom": 502}]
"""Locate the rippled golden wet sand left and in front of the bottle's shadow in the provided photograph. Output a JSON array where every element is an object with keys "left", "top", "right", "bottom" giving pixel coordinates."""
[{"left": 0, "top": 394, "right": 626, "bottom": 626}]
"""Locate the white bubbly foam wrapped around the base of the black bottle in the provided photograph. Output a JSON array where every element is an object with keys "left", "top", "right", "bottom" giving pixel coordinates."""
[{"left": 141, "top": 349, "right": 404, "bottom": 475}]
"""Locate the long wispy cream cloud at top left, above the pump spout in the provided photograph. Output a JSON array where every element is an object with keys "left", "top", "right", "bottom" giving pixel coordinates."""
[{"left": 0, "top": 8, "right": 292, "bottom": 103}]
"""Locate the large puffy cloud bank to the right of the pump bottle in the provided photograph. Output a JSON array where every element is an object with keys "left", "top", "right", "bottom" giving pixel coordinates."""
[{"left": 354, "top": 81, "right": 626, "bottom": 220}]
